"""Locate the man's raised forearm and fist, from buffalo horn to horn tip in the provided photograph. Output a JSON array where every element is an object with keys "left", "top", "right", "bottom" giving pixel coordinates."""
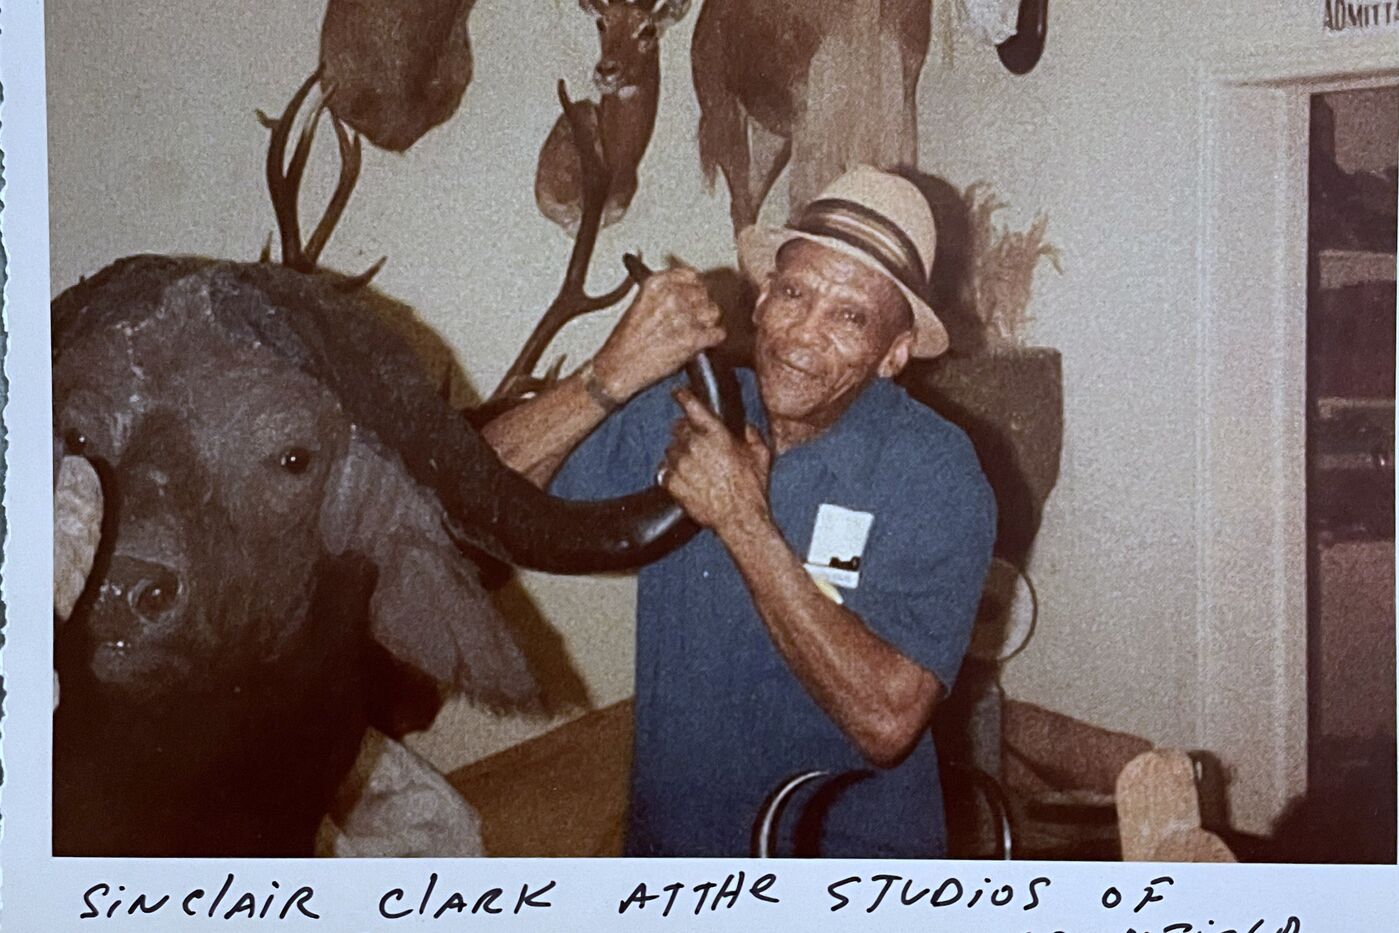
[{"left": 481, "top": 269, "right": 723, "bottom": 488}]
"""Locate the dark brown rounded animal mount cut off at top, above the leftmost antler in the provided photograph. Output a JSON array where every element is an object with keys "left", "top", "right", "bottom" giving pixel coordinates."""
[{"left": 320, "top": 0, "right": 476, "bottom": 152}]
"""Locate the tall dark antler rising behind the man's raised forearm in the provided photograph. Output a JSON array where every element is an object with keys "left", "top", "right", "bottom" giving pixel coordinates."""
[{"left": 487, "top": 81, "right": 635, "bottom": 404}]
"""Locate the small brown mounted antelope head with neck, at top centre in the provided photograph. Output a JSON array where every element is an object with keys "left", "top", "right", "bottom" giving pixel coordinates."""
[{"left": 534, "top": 0, "right": 690, "bottom": 236}]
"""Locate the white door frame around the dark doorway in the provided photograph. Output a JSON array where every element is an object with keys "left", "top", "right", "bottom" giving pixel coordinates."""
[{"left": 1196, "top": 34, "right": 1399, "bottom": 832}]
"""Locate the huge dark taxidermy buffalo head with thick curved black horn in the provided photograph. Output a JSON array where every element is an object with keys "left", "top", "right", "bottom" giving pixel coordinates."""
[{"left": 53, "top": 256, "right": 693, "bottom": 855}]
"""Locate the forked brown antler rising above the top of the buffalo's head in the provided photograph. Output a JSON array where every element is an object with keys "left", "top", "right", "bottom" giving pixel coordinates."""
[{"left": 257, "top": 67, "right": 383, "bottom": 285}]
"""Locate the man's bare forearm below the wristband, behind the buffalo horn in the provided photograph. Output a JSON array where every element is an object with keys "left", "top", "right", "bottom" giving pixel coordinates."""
[{"left": 481, "top": 372, "right": 607, "bottom": 488}]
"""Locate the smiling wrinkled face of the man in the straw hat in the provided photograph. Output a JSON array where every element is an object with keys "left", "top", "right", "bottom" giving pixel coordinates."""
[{"left": 753, "top": 239, "right": 914, "bottom": 431}]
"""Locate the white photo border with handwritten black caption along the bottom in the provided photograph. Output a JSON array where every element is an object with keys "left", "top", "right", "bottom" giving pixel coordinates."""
[{"left": 0, "top": 0, "right": 1399, "bottom": 933}]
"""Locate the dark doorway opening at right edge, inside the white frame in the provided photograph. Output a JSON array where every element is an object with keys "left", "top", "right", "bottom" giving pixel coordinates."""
[{"left": 1303, "top": 84, "right": 1399, "bottom": 863}]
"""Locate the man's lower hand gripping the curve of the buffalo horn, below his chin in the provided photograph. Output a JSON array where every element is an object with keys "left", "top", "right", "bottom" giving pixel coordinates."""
[{"left": 662, "top": 389, "right": 772, "bottom": 541}]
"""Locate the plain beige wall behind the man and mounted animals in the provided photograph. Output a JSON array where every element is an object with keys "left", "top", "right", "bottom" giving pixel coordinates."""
[{"left": 49, "top": 0, "right": 1399, "bottom": 822}]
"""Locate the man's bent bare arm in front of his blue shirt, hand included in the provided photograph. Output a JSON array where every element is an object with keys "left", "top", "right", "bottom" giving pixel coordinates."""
[{"left": 665, "top": 392, "right": 989, "bottom": 768}]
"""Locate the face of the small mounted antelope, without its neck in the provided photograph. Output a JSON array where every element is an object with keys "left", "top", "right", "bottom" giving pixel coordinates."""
[{"left": 578, "top": 0, "right": 690, "bottom": 97}]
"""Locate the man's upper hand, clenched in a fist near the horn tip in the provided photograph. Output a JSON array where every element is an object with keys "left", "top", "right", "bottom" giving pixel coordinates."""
[{"left": 593, "top": 267, "right": 723, "bottom": 401}]
